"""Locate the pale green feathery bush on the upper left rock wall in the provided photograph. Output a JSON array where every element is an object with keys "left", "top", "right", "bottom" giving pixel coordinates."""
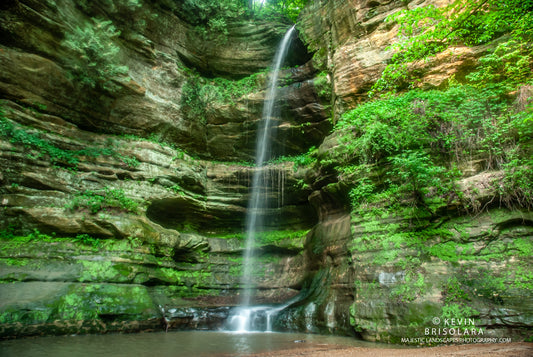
[{"left": 63, "top": 18, "right": 129, "bottom": 91}]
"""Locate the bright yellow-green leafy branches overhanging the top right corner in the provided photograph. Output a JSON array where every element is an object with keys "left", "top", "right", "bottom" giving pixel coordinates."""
[{"left": 369, "top": 0, "right": 533, "bottom": 96}]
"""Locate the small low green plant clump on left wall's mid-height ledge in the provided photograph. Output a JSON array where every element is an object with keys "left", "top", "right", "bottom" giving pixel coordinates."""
[{"left": 66, "top": 187, "right": 139, "bottom": 214}]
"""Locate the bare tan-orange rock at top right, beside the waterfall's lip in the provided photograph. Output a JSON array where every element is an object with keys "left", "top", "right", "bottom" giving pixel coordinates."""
[{"left": 298, "top": 0, "right": 487, "bottom": 114}]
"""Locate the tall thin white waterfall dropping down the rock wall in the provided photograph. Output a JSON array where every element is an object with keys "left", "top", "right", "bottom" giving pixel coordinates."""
[{"left": 229, "top": 26, "right": 294, "bottom": 332}]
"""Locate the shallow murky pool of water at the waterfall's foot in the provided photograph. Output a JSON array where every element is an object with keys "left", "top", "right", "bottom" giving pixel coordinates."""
[{"left": 0, "top": 331, "right": 390, "bottom": 357}]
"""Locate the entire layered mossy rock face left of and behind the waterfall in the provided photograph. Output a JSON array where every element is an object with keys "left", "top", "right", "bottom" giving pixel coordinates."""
[{"left": 0, "top": 0, "right": 330, "bottom": 337}]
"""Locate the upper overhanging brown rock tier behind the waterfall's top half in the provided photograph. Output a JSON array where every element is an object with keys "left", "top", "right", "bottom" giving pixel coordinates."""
[{"left": 0, "top": 1, "right": 330, "bottom": 161}]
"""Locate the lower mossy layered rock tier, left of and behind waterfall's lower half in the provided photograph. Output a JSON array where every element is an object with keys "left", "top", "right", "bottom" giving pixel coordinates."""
[{"left": 0, "top": 97, "right": 314, "bottom": 336}]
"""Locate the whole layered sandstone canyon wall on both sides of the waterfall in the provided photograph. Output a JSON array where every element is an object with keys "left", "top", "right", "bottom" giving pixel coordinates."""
[{"left": 0, "top": 0, "right": 533, "bottom": 342}]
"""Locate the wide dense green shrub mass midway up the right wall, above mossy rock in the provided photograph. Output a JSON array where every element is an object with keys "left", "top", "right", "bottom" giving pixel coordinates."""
[{"left": 330, "top": 82, "right": 533, "bottom": 211}]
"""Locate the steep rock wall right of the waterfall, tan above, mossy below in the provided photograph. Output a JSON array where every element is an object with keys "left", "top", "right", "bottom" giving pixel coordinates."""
[{"left": 279, "top": 0, "right": 533, "bottom": 343}]
